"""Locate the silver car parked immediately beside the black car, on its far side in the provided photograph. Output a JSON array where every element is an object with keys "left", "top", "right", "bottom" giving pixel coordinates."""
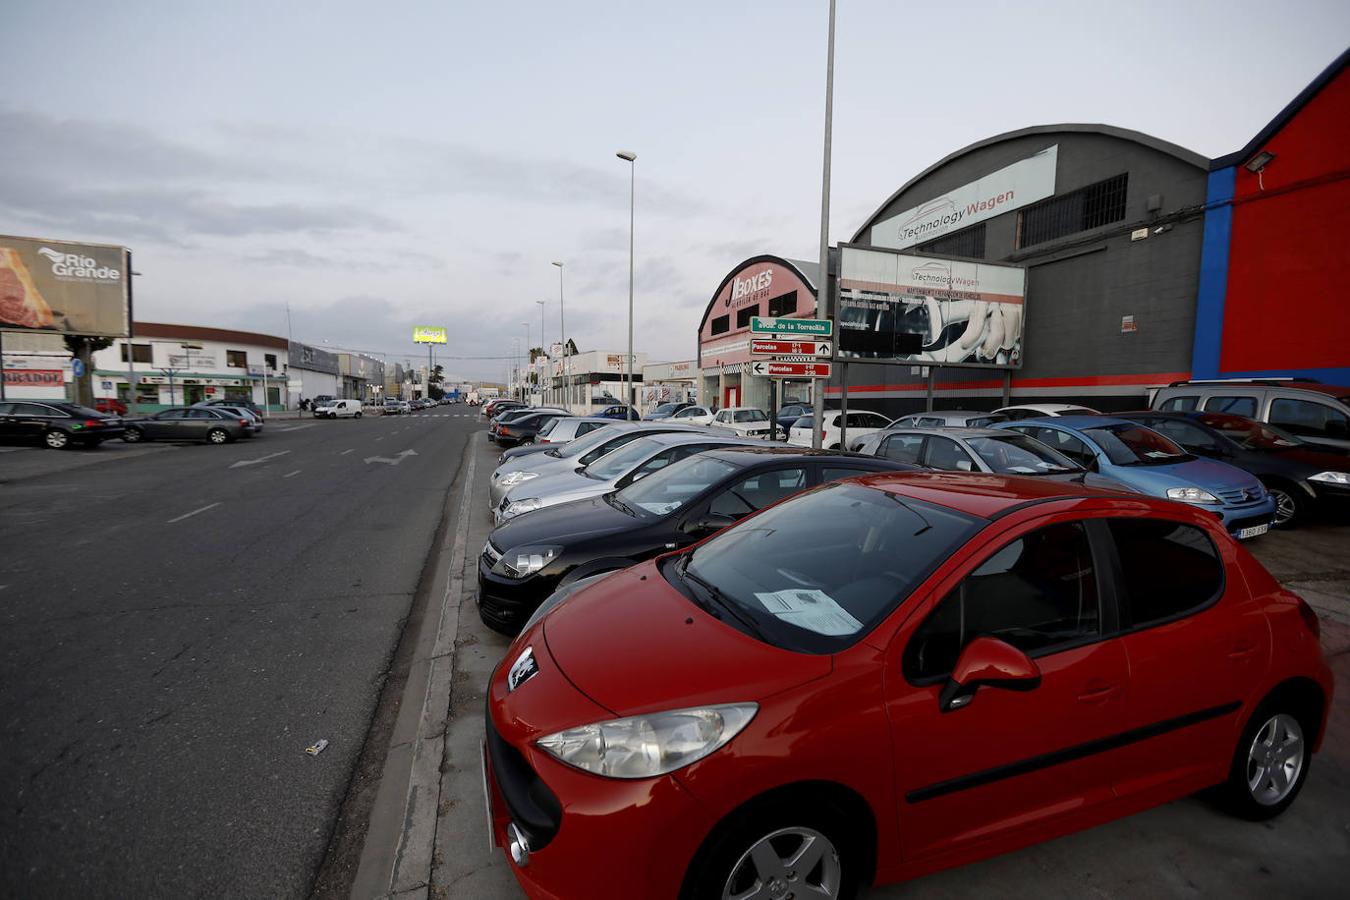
[{"left": 493, "top": 429, "right": 763, "bottom": 525}]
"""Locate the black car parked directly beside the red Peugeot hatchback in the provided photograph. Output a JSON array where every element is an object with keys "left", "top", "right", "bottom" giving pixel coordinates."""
[{"left": 478, "top": 447, "right": 915, "bottom": 634}]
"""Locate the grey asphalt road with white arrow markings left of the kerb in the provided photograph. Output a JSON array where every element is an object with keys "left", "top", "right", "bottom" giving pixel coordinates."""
[{"left": 0, "top": 407, "right": 481, "bottom": 897}]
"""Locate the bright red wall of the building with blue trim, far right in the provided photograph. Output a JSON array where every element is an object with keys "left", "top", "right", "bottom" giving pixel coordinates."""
[{"left": 1220, "top": 69, "right": 1350, "bottom": 372}]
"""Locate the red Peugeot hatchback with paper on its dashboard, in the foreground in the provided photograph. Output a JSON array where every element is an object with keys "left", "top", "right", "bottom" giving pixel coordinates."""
[{"left": 483, "top": 472, "right": 1331, "bottom": 900}]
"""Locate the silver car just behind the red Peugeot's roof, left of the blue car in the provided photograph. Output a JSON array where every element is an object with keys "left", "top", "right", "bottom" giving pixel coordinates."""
[{"left": 860, "top": 428, "right": 1138, "bottom": 494}]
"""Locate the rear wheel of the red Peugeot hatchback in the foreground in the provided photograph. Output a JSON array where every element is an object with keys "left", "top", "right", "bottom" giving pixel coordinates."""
[{"left": 1218, "top": 699, "right": 1315, "bottom": 822}]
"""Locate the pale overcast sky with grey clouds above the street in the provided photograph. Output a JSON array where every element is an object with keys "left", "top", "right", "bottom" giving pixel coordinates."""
[{"left": 0, "top": 0, "right": 1350, "bottom": 378}]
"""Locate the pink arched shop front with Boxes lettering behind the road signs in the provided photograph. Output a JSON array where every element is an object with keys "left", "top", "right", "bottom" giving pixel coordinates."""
[{"left": 698, "top": 255, "right": 819, "bottom": 412}]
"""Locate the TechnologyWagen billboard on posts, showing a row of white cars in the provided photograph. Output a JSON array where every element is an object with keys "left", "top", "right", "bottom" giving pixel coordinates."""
[{"left": 836, "top": 244, "right": 1026, "bottom": 368}]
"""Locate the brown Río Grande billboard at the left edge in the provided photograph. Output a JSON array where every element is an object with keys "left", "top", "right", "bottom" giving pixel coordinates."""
[{"left": 0, "top": 235, "right": 131, "bottom": 337}]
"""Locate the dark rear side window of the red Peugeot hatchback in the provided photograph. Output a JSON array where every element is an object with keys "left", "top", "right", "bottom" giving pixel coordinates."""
[{"left": 1107, "top": 518, "right": 1223, "bottom": 627}]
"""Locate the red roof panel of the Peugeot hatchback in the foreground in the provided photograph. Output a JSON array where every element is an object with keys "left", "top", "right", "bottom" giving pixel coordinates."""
[{"left": 857, "top": 472, "right": 1145, "bottom": 518}]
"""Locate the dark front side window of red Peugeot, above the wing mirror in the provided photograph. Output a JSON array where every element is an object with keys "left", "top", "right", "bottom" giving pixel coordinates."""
[{"left": 903, "top": 522, "right": 1102, "bottom": 681}]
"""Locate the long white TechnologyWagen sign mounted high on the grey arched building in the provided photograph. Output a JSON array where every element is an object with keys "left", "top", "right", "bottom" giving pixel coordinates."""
[{"left": 872, "top": 144, "right": 1060, "bottom": 250}]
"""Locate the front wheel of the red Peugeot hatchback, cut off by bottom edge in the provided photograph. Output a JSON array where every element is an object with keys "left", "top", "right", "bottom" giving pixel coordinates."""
[{"left": 680, "top": 800, "right": 860, "bottom": 900}]
